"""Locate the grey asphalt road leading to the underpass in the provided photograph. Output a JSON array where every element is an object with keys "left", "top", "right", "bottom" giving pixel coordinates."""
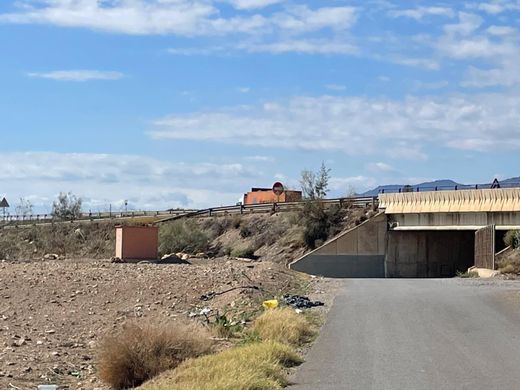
[{"left": 290, "top": 279, "right": 520, "bottom": 390}]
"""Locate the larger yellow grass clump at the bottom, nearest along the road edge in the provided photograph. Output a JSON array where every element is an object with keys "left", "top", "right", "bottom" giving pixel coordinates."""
[{"left": 139, "top": 342, "right": 302, "bottom": 390}]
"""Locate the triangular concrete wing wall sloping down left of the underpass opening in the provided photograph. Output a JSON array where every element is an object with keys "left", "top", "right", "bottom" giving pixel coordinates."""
[{"left": 290, "top": 213, "right": 387, "bottom": 278}]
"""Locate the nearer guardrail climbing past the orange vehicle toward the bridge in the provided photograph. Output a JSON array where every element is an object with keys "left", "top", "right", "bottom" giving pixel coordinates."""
[{"left": 156, "top": 196, "right": 378, "bottom": 223}]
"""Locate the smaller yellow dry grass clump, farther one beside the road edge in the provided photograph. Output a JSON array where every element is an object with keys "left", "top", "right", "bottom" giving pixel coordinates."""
[{"left": 252, "top": 308, "right": 316, "bottom": 345}]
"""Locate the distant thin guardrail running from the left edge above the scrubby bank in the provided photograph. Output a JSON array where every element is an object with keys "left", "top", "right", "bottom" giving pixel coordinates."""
[{"left": 0, "top": 209, "right": 196, "bottom": 225}]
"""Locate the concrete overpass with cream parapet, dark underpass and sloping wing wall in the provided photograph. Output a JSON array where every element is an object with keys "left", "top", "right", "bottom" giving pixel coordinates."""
[{"left": 290, "top": 188, "right": 520, "bottom": 277}]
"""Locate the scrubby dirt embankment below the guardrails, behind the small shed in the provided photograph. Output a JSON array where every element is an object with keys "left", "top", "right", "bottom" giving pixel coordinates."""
[{"left": 0, "top": 207, "right": 370, "bottom": 264}]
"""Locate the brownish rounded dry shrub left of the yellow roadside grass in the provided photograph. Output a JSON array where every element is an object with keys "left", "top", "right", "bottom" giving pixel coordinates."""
[{"left": 98, "top": 323, "right": 212, "bottom": 389}]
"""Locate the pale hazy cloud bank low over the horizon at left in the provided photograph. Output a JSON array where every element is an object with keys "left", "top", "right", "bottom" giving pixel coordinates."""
[{"left": 0, "top": 152, "right": 263, "bottom": 212}]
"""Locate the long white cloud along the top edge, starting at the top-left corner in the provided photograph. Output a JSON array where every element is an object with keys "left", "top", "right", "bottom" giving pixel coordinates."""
[{"left": 0, "top": 0, "right": 356, "bottom": 36}]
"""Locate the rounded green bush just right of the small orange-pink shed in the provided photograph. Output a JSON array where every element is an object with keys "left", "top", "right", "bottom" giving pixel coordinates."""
[{"left": 159, "top": 220, "right": 210, "bottom": 255}]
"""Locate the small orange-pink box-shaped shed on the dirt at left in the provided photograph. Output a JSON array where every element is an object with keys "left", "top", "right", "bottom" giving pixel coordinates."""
[{"left": 116, "top": 226, "right": 159, "bottom": 260}]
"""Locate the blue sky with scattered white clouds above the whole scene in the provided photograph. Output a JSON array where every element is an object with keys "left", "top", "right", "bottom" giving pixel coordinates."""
[{"left": 0, "top": 0, "right": 520, "bottom": 213}]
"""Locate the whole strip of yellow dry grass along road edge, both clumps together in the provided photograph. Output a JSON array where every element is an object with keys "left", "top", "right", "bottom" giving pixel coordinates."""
[{"left": 127, "top": 308, "right": 316, "bottom": 390}]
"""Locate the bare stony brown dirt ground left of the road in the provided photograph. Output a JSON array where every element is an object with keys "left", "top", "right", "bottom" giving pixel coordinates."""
[{"left": 0, "top": 259, "right": 319, "bottom": 390}]
